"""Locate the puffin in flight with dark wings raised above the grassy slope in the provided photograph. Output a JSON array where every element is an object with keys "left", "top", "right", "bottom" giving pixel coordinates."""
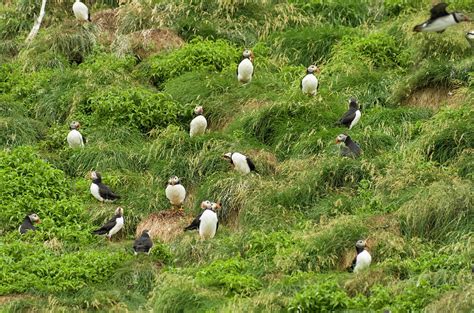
[{"left": 413, "top": 2, "right": 470, "bottom": 33}]
